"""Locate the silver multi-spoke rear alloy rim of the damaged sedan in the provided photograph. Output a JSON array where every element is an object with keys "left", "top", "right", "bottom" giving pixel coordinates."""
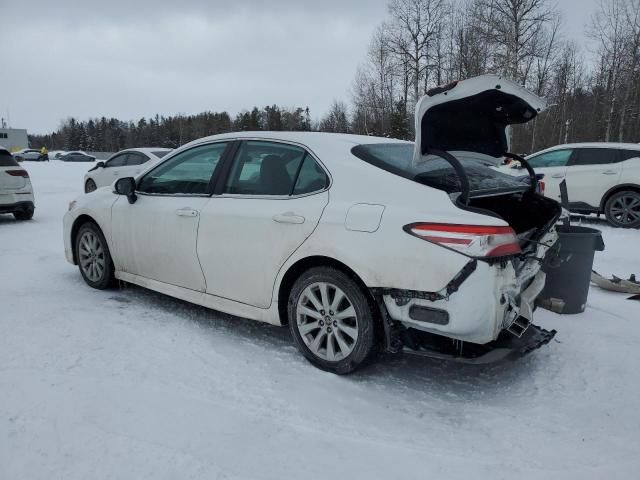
[{"left": 296, "top": 282, "right": 358, "bottom": 362}]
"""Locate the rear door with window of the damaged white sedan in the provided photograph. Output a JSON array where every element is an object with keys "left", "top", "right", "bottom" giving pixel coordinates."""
[{"left": 198, "top": 140, "right": 329, "bottom": 308}]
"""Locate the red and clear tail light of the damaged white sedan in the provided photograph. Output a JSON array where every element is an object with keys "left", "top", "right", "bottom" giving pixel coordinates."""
[{"left": 404, "top": 223, "right": 522, "bottom": 258}]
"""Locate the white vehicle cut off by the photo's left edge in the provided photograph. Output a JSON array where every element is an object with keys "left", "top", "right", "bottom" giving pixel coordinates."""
[{"left": 0, "top": 147, "right": 35, "bottom": 220}]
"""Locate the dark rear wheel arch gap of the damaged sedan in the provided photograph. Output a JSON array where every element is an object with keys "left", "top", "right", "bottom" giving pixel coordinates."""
[{"left": 277, "top": 255, "right": 379, "bottom": 325}]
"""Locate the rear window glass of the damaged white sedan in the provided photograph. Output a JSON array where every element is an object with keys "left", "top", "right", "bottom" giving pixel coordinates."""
[{"left": 351, "top": 143, "right": 528, "bottom": 196}]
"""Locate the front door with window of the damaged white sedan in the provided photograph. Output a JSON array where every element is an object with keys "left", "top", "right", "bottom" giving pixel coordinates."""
[{"left": 112, "top": 142, "right": 229, "bottom": 291}]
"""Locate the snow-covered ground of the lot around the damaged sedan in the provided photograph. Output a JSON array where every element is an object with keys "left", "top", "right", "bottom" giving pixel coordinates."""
[{"left": 0, "top": 161, "right": 640, "bottom": 480}]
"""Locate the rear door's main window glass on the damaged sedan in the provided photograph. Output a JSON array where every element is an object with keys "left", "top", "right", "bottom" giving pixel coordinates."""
[{"left": 224, "top": 140, "right": 306, "bottom": 195}]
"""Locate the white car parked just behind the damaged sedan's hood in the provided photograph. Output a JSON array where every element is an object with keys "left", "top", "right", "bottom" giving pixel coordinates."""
[{"left": 84, "top": 148, "right": 171, "bottom": 193}]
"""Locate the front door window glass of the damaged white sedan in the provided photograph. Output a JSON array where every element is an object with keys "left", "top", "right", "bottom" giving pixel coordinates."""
[{"left": 138, "top": 142, "right": 227, "bottom": 195}]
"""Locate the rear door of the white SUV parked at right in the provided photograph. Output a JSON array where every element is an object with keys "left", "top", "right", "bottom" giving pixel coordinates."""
[{"left": 567, "top": 148, "right": 622, "bottom": 209}]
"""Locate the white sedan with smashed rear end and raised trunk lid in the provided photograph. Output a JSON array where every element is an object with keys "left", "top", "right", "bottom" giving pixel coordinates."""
[{"left": 64, "top": 75, "right": 561, "bottom": 374}]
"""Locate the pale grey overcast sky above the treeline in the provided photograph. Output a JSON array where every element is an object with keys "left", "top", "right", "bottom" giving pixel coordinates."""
[{"left": 0, "top": 0, "right": 597, "bottom": 133}]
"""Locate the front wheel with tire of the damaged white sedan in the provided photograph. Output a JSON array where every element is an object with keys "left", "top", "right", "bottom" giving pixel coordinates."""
[{"left": 74, "top": 222, "right": 115, "bottom": 290}]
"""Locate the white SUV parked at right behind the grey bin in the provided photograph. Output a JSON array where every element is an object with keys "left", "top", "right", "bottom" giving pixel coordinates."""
[{"left": 527, "top": 143, "right": 640, "bottom": 228}]
